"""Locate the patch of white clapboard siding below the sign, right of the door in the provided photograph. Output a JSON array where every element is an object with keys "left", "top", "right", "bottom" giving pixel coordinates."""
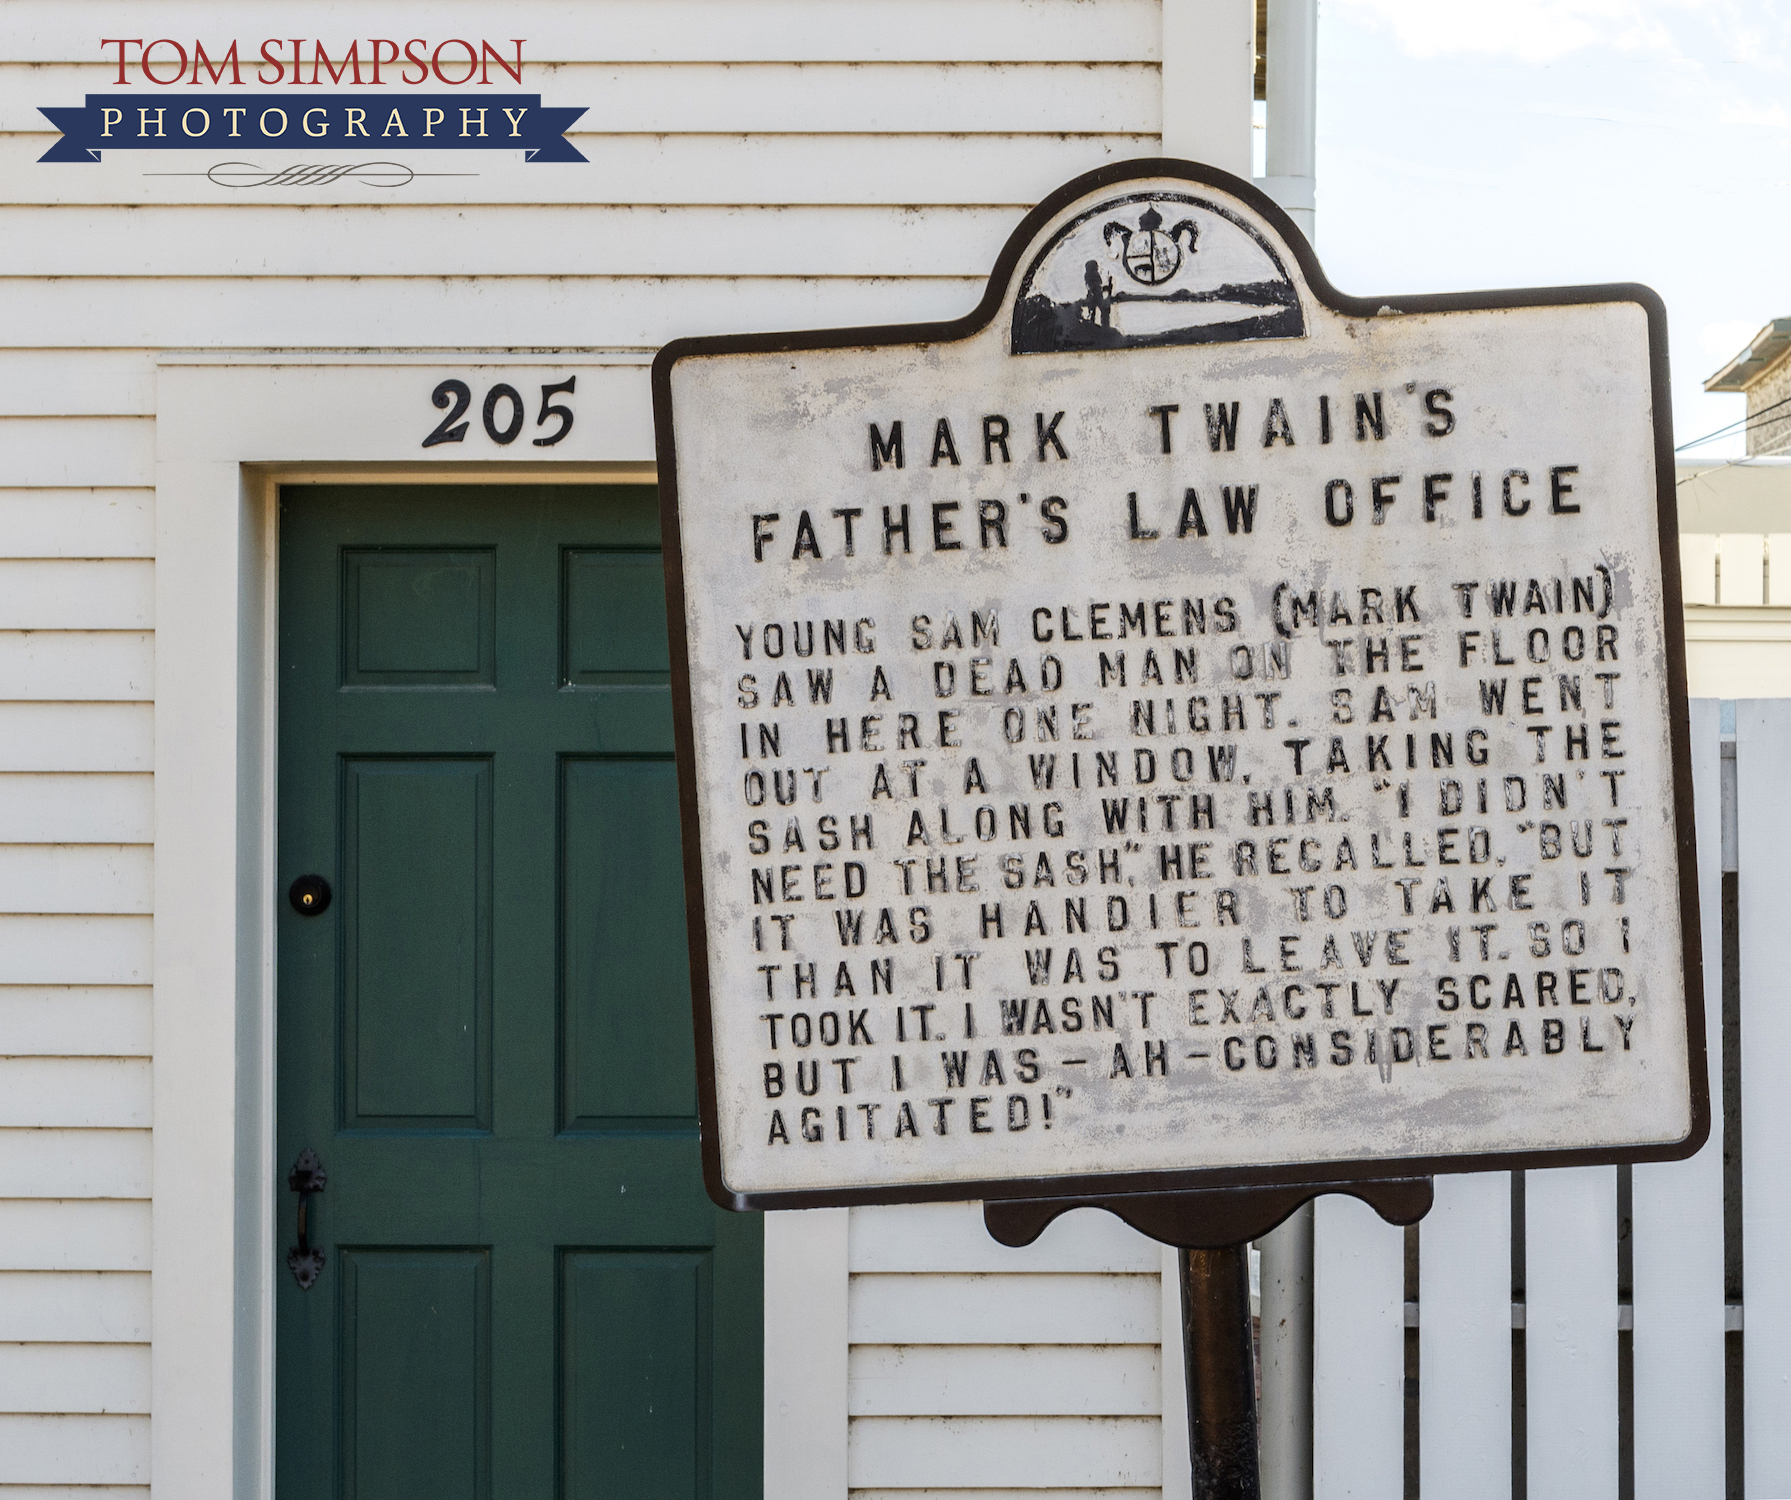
[{"left": 847, "top": 1203, "right": 1162, "bottom": 1496}]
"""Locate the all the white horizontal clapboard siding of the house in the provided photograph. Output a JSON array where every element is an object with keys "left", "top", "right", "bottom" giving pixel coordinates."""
[{"left": 0, "top": 0, "right": 1162, "bottom": 1500}]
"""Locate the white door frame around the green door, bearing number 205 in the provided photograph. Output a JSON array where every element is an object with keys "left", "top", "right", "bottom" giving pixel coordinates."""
[{"left": 150, "top": 354, "right": 845, "bottom": 1500}]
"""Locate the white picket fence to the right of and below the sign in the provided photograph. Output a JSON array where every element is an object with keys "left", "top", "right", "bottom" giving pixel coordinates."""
[{"left": 1296, "top": 698, "right": 1769, "bottom": 1500}]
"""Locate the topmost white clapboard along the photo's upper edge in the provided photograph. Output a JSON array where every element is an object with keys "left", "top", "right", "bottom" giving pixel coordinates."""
[{"left": 7, "top": 0, "right": 1161, "bottom": 63}]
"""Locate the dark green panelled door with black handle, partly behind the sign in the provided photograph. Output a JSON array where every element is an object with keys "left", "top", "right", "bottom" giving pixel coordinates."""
[{"left": 276, "top": 485, "right": 761, "bottom": 1500}]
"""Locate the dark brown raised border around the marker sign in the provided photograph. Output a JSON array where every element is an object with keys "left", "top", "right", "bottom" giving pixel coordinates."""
[{"left": 652, "top": 158, "right": 1710, "bottom": 1210}]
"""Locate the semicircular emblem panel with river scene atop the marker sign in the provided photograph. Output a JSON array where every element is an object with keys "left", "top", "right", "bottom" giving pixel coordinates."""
[{"left": 1012, "top": 190, "right": 1306, "bottom": 354}]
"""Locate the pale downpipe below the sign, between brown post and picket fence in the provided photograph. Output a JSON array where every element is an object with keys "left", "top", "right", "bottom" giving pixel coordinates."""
[{"left": 1257, "top": 1203, "right": 1313, "bottom": 1500}]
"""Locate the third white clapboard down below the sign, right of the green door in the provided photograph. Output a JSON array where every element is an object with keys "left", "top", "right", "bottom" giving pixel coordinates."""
[{"left": 848, "top": 1353, "right": 1162, "bottom": 1416}]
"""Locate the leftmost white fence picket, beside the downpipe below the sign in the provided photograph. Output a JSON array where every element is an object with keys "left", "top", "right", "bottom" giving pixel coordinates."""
[{"left": 1313, "top": 1196, "right": 1406, "bottom": 1500}]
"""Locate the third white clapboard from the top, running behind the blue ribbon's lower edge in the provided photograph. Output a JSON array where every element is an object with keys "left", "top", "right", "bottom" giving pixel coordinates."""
[{"left": 0, "top": 133, "right": 1161, "bottom": 210}]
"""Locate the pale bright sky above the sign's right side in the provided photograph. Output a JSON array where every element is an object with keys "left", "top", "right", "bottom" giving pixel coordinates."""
[{"left": 1316, "top": 0, "right": 1791, "bottom": 458}]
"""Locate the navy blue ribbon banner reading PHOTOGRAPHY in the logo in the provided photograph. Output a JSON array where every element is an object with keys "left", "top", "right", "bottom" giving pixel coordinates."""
[{"left": 38, "top": 93, "right": 586, "bottom": 161}]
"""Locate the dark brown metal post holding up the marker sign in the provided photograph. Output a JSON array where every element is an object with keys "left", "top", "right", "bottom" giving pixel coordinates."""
[{"left": 1180, "top": 1244, "right": 1261, "bottom": 1500}]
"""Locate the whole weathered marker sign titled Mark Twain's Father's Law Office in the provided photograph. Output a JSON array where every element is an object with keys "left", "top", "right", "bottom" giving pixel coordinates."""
[{"left": 654, "top": 161, "right": 1709, "bottom": 1206}]
